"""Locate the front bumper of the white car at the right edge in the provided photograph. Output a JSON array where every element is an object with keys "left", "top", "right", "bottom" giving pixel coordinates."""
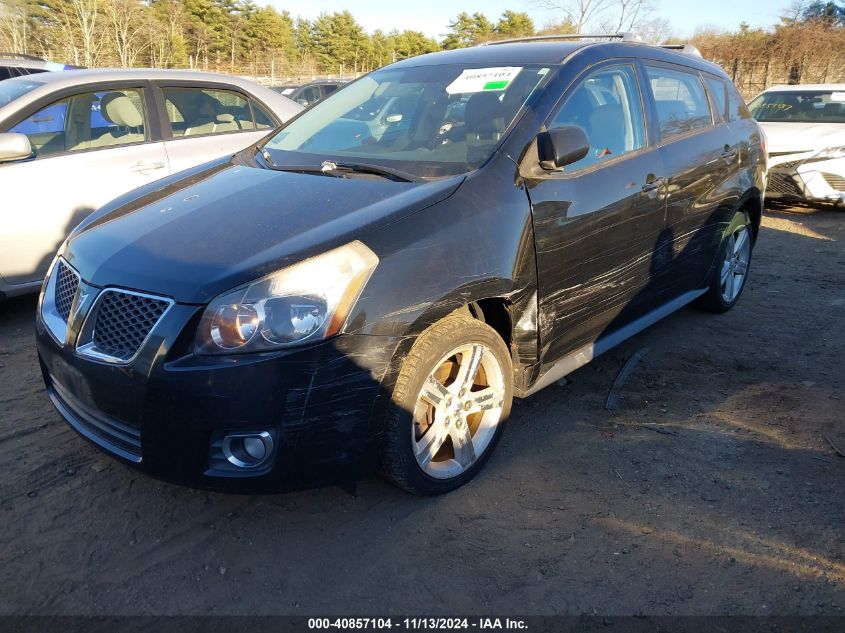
[{"left": 766, "top": 154, "right": 845, "bottom": 204}]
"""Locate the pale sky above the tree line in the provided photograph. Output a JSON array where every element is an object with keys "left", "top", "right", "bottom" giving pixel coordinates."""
[{"left": 268, "top": 0, "right": 789, "bottom": 39}]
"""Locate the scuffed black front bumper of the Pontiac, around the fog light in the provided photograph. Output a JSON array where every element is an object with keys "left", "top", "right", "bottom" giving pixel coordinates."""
[{"left": 36, "top": 304, "right": 406, "bottom": 493}]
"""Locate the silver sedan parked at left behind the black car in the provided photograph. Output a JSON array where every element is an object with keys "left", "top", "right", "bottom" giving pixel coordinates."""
[{"left": 0, "top": 69, "right": 302, "bottom": 299}]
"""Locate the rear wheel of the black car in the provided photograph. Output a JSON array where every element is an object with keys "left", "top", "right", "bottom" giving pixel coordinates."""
[{"left": 695, "top": 210, "right": 754, "bottom": 314}]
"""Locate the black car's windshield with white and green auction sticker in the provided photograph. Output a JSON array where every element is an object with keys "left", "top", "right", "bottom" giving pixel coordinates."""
[{"left": 265, "top": 65, "right": 549, "bottom": 177}]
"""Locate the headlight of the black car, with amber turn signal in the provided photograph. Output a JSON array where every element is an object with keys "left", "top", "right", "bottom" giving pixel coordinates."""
[{"left": 195, "top": 242, "right": 378, "bottom": 354}]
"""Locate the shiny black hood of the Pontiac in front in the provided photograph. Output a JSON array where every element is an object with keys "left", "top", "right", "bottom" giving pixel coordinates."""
[{"left": 63, "top": 157, "right": 464, "bottom": 304}]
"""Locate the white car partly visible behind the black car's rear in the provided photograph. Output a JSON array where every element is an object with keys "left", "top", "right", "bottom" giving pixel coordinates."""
[{"left": 748, "top": 84, "right": 845, "bottom": 204}]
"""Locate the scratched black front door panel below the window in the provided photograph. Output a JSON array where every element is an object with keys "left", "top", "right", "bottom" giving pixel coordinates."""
[{"left": 529, "top": 145, "right": 664, "bottom": 363}]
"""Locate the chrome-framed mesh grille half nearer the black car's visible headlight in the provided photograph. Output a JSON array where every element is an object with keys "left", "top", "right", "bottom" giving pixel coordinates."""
[{"left": 85, "top": 289, "right": 172, "bottom": 362}]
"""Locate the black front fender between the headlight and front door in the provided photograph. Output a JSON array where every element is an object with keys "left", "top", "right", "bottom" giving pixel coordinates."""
[{"left": 347, "top": 154, "right": 536, "bottom": 355}]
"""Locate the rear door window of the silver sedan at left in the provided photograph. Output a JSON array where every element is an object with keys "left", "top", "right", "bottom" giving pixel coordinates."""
[{"left": 162, "top": 88, "right": 255, "bottom": 138}]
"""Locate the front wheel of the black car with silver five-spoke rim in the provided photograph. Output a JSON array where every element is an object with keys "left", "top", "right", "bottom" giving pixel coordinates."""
[{"left": 380, "top": 314, "right": 513, "bottom": 495}]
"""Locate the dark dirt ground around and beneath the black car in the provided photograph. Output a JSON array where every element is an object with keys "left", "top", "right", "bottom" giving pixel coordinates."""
[{"left": 0, "top": 204, "right": 845, "bottom": 615}]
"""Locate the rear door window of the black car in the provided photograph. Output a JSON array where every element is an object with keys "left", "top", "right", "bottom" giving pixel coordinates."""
[{"left": 646, "top": 66, "right": 711, "bottom": 141}]
